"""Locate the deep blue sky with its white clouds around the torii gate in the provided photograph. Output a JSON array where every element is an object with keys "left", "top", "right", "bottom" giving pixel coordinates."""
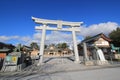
[{"left": 0, "top": 0, "right": 120, "bottom": 44}]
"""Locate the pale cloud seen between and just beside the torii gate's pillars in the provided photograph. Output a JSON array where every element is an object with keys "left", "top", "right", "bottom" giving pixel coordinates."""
[{"left": 31, "top": 31, "right": 81, "bottom": 44}]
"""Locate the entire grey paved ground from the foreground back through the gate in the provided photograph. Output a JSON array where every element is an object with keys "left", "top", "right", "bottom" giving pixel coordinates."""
[{"left": 0, "top": 58, "right": 120, "bottom": 80}]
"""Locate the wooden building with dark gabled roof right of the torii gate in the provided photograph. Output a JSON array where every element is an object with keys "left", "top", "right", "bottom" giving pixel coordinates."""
[{"left": 78, "top": 33, "right": 112, "bottom": 57}]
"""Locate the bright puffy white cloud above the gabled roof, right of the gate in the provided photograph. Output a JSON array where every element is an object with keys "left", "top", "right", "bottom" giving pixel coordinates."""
[{"left": 79, "top": 22, "right": 119, "bottom": 37}]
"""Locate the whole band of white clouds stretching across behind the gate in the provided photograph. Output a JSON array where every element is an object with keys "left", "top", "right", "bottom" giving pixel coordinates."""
[{"left": 0, "top": 22, "right": 119, "bottom": 45}]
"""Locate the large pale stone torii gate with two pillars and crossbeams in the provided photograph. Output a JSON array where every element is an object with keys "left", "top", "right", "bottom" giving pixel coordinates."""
[{"left": 32, "top": 17, "right": 83, "bottom": 64}]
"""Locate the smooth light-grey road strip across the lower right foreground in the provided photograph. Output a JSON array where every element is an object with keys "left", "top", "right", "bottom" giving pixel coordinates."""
[{"left": 21, "top": 68, "right": 120, "bottom": 80}]
